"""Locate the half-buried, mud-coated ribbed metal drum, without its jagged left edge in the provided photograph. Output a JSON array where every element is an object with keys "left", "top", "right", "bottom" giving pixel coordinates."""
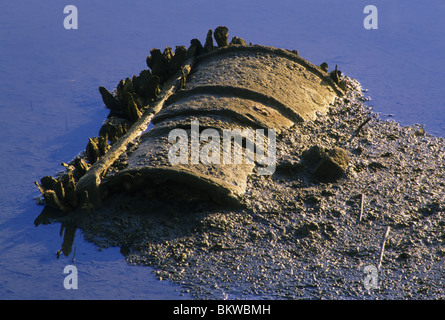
[{"left": 101, "top": 45, "right": 342, "bottom": 203}]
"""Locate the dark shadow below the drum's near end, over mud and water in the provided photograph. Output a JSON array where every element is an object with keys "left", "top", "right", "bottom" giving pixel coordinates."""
[{"left": 34, "top": 190, "right": 227, "bottom": 257}]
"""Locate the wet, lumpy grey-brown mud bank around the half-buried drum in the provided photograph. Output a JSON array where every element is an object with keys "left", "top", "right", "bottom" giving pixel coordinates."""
[{"left": 37, "top": 78, "right": 445, "bottom": 299}]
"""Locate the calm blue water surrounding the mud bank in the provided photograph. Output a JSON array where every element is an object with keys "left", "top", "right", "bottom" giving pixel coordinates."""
[{"left": 0, "top": 0, "right": 445, "bottom": 299}]
